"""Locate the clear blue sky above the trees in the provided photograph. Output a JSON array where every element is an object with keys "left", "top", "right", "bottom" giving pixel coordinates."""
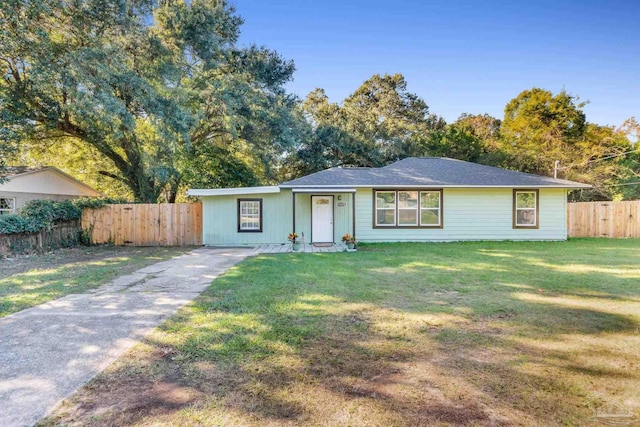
[{"left": 230, "top": 0, "right": 640, "bottom": 126}]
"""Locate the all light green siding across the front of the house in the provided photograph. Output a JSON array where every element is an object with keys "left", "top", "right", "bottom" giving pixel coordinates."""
[{"left": 202, "top": 188, "right": 567, "bottom": 246}]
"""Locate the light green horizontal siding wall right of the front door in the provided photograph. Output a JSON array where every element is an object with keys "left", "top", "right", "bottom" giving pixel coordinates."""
[{"left": 356, "top": 188, "right": 567, "bottom": 242}]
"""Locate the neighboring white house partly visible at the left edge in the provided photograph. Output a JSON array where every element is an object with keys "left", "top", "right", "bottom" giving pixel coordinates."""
[{"left": 0, "top": 166, "right": 101, "bottom": 215}]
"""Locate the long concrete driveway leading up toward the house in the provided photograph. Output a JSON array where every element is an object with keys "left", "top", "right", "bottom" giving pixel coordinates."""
[{"left": 0, "top": 248, "right": 253, "bottom": 427}]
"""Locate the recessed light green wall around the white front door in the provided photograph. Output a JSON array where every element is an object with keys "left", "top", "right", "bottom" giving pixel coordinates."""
[{"left": 296, "top": 193, "right": 353, "bottom": 243}]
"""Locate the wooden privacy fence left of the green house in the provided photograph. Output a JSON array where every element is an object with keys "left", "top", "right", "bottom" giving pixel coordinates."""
[{"left": 82, "top": 203, "right": 202, "bottom": 246}]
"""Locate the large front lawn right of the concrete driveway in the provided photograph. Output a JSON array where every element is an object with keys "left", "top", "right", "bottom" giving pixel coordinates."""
[{"left": 43, "top": 239, "right": 640, "bottom": 426}]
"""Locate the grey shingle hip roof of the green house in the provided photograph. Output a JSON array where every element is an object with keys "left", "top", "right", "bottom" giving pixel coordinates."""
[{"left": 280, "top": 157, "right": 591, "bottom": 188}]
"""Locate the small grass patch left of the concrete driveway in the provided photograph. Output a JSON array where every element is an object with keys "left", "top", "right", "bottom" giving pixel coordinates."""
[{"left": 0, "top": 246, "right": 190, "bottom": 317}]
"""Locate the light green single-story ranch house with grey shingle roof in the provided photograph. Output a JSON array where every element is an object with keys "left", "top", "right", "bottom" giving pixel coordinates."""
[{"left": 188, "top": 158, "right": 591, "bottom": 245}]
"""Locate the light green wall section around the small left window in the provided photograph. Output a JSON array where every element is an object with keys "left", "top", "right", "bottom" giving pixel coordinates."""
[{"left": 202, "top": 190, "right": 293, "bottom": 246}]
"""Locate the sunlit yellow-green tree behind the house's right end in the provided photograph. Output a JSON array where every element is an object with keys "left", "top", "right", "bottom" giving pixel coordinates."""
[{"left": 500, "top": 88, "right": 639, "bottom": 201}]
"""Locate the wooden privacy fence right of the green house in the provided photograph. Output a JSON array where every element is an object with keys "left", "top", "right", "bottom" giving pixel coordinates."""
[{"left": 567, "top": 200, "right": 640, "bottom": 238}]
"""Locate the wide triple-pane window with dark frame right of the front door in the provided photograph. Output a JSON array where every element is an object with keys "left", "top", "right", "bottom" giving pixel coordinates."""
[{"left": 374, "top": 190, "right": 442, "bottom": 228}]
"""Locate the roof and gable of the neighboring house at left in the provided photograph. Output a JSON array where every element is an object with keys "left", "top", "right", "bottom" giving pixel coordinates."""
[{"left": 0, "top": 166, "right": 102, "bottom": 197}]
